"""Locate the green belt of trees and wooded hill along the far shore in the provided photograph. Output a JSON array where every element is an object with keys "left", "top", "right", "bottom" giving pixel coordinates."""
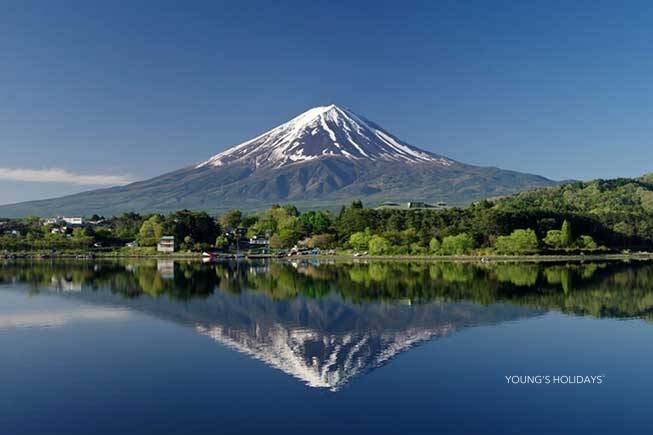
[{"left": 0, "top": 174, "right": 653, "bottom": 255}]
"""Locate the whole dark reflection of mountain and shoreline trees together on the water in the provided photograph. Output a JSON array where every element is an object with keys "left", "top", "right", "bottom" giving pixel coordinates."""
[{"left": 5, "top": 261, "right": 653, "bottom": 390}]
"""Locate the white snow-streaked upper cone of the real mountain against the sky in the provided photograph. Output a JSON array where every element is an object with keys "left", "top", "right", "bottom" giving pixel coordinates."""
[{"left": 197, "top": 104, "right": 453, "bottom": 168}]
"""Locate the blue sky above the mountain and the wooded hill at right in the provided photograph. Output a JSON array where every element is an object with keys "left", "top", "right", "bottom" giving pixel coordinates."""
[{"left": 0, "top": 0, "right": 653, "bottom": 203}]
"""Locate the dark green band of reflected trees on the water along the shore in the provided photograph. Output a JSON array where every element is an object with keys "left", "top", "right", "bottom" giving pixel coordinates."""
[{"left": 0, "top": 260, "right": 653, "bottom": 318}]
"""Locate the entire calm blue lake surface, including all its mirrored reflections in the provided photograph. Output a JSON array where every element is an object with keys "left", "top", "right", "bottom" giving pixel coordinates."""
[{"left": 0, "top": 260, "right": 653, "bottom": 435}]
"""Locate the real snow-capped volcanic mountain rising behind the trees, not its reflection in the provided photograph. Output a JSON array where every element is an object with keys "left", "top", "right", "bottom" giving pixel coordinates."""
[{"left": 0, "top": 105, "right": 556, "bottom": 217}]
